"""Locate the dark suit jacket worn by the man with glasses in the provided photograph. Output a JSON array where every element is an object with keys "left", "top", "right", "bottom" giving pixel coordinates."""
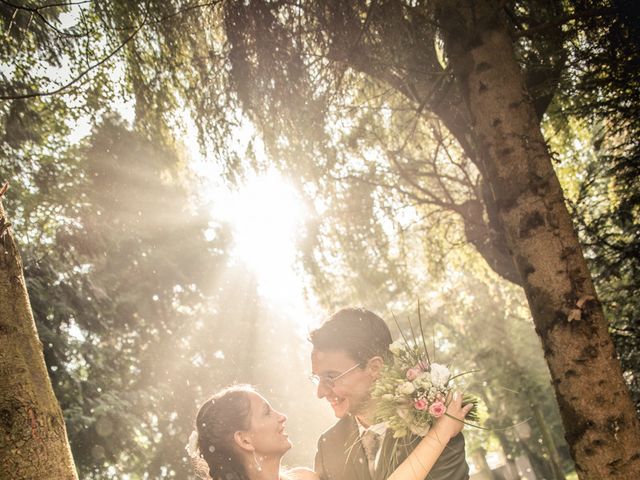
[{"left": 315, "top": 415, "right": 469, "bottom": 480}]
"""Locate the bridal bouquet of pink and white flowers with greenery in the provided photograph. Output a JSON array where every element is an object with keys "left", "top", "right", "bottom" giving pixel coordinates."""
[{"left": 371, "top": 316, "right": 478, "bottom": 438}]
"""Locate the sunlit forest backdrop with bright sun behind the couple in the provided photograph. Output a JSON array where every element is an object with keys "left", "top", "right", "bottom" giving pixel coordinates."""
[{"left": 0, "top": 0, "right": 640, "bottom": 479}]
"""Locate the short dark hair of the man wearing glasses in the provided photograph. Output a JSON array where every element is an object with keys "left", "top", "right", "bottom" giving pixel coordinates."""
[{"left": 309, "top": 307, "right": 392, "bottom": 364}]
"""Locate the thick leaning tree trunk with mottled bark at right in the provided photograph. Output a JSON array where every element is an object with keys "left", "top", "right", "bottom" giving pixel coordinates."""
[{"left": 436, "top": 0, "right": 640, "bottom": 480}]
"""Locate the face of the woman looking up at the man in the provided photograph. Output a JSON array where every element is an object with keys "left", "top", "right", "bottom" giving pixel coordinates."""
[{"left": 248, "top": 392, "right": 291, "bottom": 457}]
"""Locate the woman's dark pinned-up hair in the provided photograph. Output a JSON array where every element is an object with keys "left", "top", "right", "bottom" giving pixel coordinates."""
[{"left": 196, "top": 385, "right": 255, "bottom": 480}]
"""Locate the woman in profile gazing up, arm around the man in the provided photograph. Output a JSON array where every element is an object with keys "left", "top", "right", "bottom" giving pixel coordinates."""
[{"left": 187, "top": 385, "right": 471, "bottom": 480}]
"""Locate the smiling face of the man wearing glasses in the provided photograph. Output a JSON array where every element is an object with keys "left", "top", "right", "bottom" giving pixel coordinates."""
[{"left": 311, "top": 349, "right": 375, "bottom": 418}]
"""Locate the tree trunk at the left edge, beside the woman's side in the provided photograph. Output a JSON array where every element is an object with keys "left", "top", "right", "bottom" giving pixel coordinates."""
[{"left": 0, "top": 195, "right": 77, "bottom": 480}]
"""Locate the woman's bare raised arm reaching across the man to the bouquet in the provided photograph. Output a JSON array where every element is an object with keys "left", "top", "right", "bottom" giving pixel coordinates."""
[{"left": 387, "top": 392, "right": 473, "bottom": 480}]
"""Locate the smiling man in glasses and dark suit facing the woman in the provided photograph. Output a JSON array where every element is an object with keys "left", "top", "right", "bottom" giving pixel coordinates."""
[{"left": 309, "top": 308, "right": 469, "bottom": 480}]
